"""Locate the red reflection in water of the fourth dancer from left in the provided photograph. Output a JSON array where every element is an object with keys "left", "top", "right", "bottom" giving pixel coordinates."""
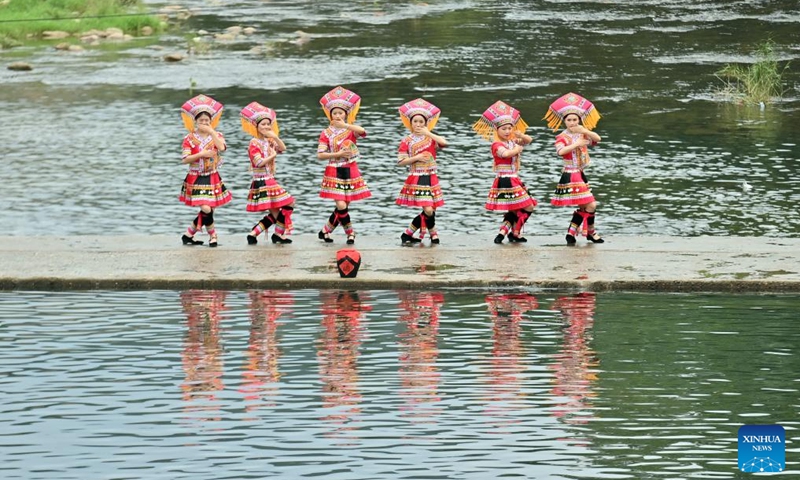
[{"left": 398, "top": 290, "right": 444, "bottom": 422}]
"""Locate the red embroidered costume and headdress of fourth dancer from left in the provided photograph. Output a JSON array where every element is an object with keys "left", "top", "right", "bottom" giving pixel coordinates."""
[{"left": 395, "top": 98, "right": 444, "bottom": 243}]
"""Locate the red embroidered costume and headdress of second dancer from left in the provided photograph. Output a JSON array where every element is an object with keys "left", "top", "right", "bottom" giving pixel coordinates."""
[{"left": 241, "top": 102, "right": 294, "bottom": 245}]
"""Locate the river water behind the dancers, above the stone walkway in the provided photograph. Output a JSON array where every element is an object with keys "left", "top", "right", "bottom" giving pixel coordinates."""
[{"left": 0, "top": 0, "right": 800, "bottom": 241}]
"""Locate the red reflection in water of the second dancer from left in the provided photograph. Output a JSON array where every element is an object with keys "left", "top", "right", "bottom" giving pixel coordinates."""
[{"left": 240, "top": 290, "right": 294, "bottom": 411}]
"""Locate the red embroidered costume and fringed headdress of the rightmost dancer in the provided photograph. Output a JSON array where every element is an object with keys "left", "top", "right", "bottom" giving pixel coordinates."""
[{"left": 544, "top": 93, "right": 603, "bottom": 244}]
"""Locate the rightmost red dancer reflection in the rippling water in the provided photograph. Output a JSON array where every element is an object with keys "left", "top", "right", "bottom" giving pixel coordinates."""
[{"left": 552, "top": 292, "right": 597, "bottom": 424}]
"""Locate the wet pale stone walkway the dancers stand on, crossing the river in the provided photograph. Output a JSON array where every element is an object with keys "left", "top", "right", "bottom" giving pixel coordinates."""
[{"left": 0, "top": 235, "right": 800, "bottom": 291}]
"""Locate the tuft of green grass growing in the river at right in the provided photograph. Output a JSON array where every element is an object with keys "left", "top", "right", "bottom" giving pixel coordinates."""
[{"left": 716, "top": 40, "right": 789, "bottom": 104}]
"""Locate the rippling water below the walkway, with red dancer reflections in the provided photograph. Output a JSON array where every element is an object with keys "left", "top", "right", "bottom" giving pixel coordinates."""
[{"left": 0, "top": 290, "right": 800, "bottom": 480}]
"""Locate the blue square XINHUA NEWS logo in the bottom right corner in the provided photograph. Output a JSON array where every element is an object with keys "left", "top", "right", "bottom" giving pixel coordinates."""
[{"left": 739, "top": 425, "right": 786, "bottom": 473}]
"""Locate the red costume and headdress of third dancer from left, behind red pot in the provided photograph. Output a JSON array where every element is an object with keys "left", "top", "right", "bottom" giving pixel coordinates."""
[{"left": 317, "top": 87, "right": 372, "bottom": 244}]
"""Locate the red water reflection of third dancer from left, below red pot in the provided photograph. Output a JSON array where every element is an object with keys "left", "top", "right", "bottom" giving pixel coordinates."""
[{"left": 317, "top": 291, "right": 372, "bottom": 434}]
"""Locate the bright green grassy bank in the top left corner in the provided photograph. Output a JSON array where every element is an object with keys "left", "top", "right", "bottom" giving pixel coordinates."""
[{"left": 0, "top": 0, "right": 161, "bottom": 47}]
